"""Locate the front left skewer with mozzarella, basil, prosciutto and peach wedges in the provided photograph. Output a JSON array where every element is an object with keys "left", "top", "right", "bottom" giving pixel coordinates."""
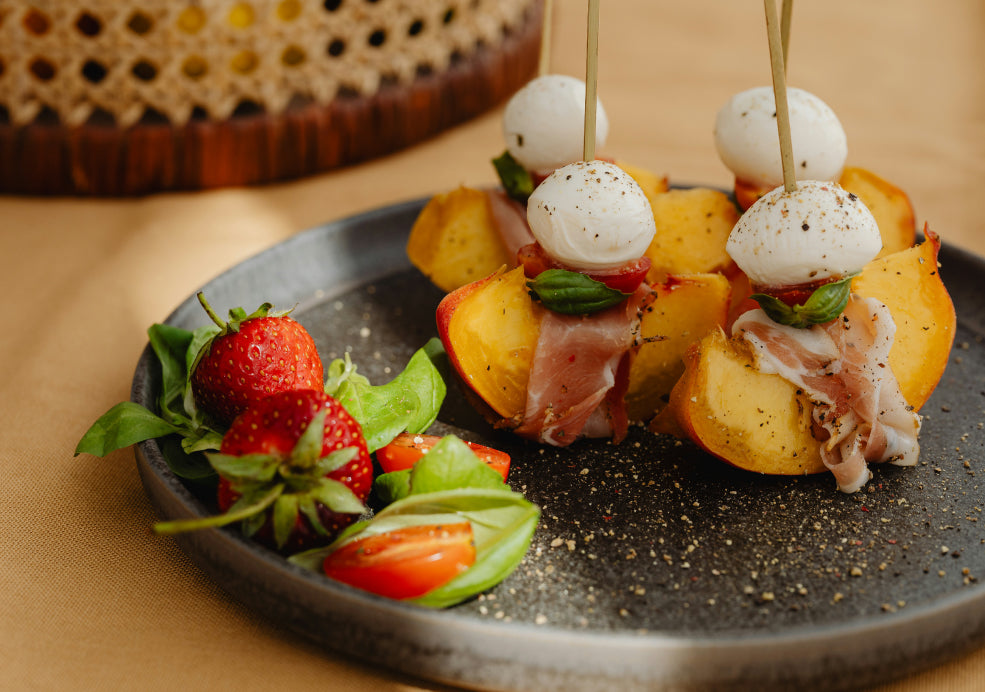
[{"left": 436, "top": 161, "right": 730, "bottom": 446}]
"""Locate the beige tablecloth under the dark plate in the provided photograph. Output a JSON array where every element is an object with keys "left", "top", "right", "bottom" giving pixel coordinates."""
[{"left": 0, "top": 0, "right": 985, "bottom": 692}]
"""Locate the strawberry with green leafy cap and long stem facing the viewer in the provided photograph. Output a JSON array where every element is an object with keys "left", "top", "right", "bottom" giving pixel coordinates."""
[{"left": 155, "top": 389, "right": 373, "bottom": 552}]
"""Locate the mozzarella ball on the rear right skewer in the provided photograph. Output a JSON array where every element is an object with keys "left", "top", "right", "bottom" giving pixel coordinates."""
[{"left": 715, "top": 87, "right": 848, "bottom": 188}]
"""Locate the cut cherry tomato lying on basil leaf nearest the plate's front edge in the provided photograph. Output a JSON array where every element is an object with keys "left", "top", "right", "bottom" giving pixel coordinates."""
[{"left": 323, "top": 521, "right": 475, "bottom": 600}]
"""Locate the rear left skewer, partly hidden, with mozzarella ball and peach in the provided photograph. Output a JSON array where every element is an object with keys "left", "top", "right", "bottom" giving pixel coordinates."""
[{"left": 407, "top": 74, "right": 667, "bottom": 292}]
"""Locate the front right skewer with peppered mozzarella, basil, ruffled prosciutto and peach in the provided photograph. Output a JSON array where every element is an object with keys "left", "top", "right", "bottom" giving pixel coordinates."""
[{"left": 651, "top": 181, "right": 955, "bottom": 492}]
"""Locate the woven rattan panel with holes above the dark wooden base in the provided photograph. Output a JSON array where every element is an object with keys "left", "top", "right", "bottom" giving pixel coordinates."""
[{"left": 0, "top": 0, "right": 532, "bottom": 127}]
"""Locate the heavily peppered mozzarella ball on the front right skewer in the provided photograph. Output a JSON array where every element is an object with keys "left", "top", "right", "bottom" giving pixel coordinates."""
[{"left": 725, "top": 180, "right": 882, "bottom": 286}]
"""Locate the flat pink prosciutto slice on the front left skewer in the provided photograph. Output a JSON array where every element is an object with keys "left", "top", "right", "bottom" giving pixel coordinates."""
[{"left": 514, "top": 283, "right": 654, "bottom": 447}]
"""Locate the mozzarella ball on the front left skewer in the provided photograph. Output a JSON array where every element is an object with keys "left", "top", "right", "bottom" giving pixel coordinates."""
[{"left": 527, "top": 161, "right": 656, "bottom": 271}]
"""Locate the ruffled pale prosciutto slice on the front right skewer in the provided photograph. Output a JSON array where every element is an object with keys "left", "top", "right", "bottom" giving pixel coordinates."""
[{"left": 732, "top": 295, "right": 920, "bottom": 493}]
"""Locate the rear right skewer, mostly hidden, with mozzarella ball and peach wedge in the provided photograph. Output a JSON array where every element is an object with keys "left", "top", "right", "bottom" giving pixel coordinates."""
[{"left": 715, "top": 86, "right": 916, "bottom": 254}]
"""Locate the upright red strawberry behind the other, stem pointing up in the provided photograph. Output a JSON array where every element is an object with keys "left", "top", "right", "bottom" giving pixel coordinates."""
[{"left": 191, "top": 293, "right": 324, "bottom": 425}]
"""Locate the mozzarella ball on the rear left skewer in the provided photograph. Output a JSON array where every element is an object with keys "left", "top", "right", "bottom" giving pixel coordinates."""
[{"left": 503, "top": 74, "right": 609, "bottom": 173}]
